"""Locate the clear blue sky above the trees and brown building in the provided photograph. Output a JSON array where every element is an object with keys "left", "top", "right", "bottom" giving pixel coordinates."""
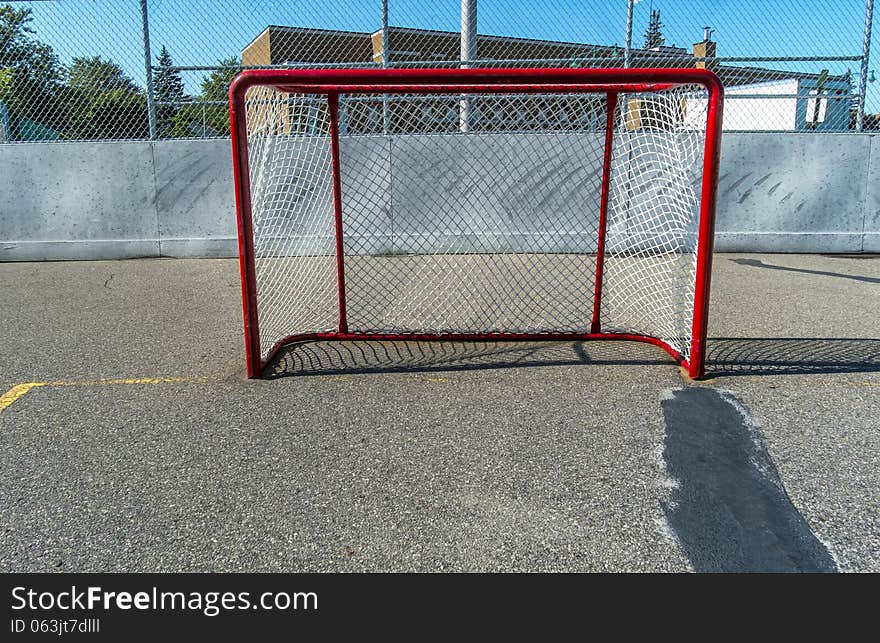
[{"left": 13, "top": 0, "right": 880, "bottom": 111}]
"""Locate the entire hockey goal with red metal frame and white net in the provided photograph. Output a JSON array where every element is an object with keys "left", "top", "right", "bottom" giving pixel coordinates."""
[{"left": 230, "top": 69, "right": 723, "bottom": 378}]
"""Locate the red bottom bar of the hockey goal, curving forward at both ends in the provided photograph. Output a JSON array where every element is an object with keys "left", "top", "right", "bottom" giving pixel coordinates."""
[{"left": 248, "top": 331, "right": 705, "bottom": 380}]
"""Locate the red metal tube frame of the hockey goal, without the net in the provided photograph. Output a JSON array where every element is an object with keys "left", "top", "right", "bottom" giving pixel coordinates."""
[{"left": 229, "top": 68, "right": 724, "bottom": 379}]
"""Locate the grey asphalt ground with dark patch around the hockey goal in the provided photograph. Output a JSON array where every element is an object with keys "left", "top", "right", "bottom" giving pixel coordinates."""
[{"left": 0, "top": 254, "right": 880, "bottom": 572}]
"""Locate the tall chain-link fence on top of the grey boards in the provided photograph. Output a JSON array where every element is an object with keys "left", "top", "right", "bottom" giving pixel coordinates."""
[{"left": 0, "top": 0, "right": 880, "bottom": 142}]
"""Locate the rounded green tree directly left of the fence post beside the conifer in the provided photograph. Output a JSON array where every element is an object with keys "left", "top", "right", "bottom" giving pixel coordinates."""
[{"left": 67, "top": 56, "right": 149, "bottom": 139}]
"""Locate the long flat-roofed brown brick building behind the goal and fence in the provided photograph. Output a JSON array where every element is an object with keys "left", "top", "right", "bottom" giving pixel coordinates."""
[{"left": 242, "top": 25, "right": 849, "bottom": 133}]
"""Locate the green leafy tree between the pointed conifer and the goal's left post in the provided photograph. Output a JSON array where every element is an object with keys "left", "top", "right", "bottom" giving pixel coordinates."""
[{"left": 172, "top": 58, "right": 241, "bottom": 137}]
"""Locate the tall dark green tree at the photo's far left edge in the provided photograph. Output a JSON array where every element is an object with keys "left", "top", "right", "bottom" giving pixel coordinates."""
[{"left": 0, "top": 4, "right": 67, "bottom": 137}]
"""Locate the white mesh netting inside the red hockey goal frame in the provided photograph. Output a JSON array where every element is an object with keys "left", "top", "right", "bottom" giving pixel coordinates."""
[{"left": 246, "top": 78, "right": 707, "bottom": 359}]
